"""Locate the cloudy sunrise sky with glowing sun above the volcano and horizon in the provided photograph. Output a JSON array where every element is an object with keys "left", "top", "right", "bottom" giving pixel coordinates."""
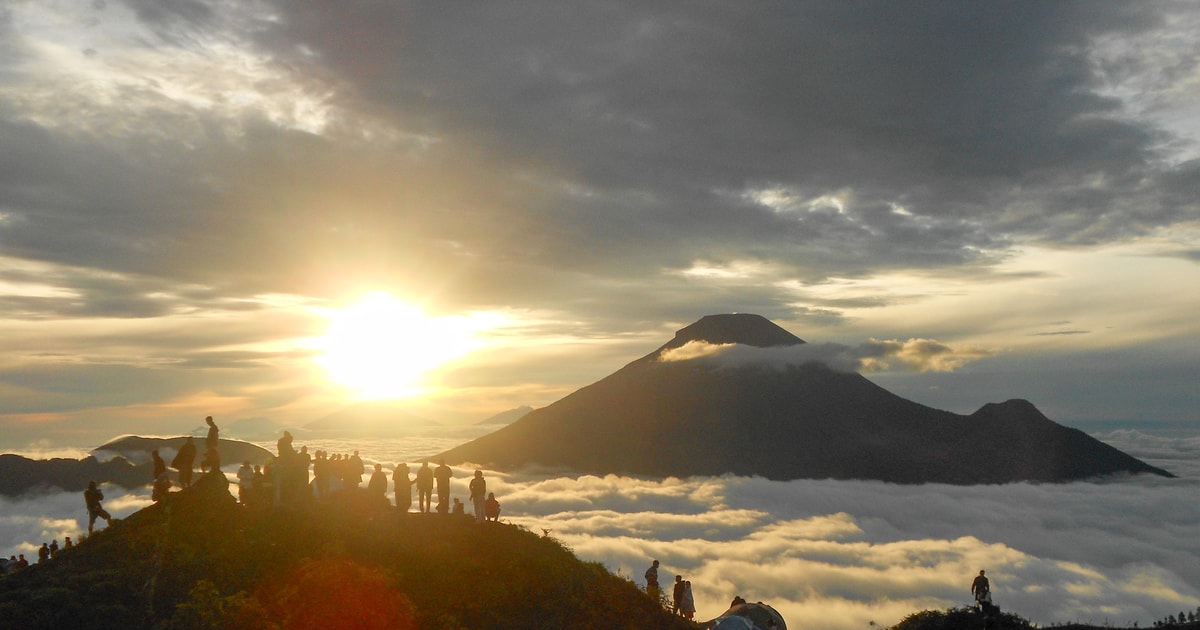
[{"left": 0, "top": 0, "right": 1200, "bottom": 449}]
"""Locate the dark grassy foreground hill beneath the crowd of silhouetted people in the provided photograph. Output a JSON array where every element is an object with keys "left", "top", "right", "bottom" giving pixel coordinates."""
[{"left": 0, "top": 474, "right": 694, "bottom": 630}]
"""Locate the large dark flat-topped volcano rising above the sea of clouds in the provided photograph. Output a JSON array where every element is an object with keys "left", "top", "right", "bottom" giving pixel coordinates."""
[{"left": 436, "top": 314, "right": 1171, "bottom": 485}]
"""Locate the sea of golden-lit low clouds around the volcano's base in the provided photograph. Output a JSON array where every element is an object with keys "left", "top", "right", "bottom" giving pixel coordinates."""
[{"left": 0, "top": 427, "right": 1200, "bottom": 629}]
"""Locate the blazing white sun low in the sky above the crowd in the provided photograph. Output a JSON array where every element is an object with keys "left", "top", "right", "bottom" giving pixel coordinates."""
[{"left": 317, "top": 292, "right": 480, "bottom": 400}]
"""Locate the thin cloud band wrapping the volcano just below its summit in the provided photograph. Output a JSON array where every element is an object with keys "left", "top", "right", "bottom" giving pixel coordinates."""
[{"left": 659, "top": 338, "right": 992, "bottom": 372}]
